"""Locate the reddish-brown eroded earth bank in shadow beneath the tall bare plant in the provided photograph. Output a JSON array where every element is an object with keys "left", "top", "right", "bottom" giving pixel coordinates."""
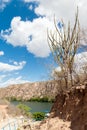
[{"left": 51, "top": 82, "right": 87, "bottom": 130}]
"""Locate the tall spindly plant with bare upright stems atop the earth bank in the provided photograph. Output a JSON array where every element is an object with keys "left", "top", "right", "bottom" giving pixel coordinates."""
[{"left": 47, "top": 9, "right": 80, "bottom": 88}]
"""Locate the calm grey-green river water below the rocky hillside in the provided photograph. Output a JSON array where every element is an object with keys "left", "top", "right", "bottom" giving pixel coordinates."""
[{"left": 12, "top": 101, "right": 53, "bottom": 112}]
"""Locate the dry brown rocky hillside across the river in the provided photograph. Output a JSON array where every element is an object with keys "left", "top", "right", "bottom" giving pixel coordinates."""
[{"left": 0, "top": 81, "right": 58, "bottom": 100}]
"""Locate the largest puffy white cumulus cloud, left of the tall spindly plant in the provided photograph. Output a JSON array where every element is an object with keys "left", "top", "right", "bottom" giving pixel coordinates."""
[{"left": 1, "top": 17, "right": 53, "bottom": 57}]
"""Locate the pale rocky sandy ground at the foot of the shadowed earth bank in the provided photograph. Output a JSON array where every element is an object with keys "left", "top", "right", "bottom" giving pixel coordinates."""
[{"left": 19, "top": 117, "right": 71, "bottom": 130}]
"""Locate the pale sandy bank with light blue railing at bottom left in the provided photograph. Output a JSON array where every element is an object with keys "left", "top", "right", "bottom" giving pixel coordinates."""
[{"left": 0, "top": 105, "right": 30, "bottom": 130}]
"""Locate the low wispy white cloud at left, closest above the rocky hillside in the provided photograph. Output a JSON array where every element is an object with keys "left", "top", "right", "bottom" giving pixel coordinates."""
[{"left": 0, "top": 76, "right": 29, "bottom": 87}]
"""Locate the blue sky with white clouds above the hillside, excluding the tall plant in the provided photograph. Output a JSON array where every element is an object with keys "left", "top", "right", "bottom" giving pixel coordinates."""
[{"left": 0, "top": 0, "right": 87, "bottom": 87}]
